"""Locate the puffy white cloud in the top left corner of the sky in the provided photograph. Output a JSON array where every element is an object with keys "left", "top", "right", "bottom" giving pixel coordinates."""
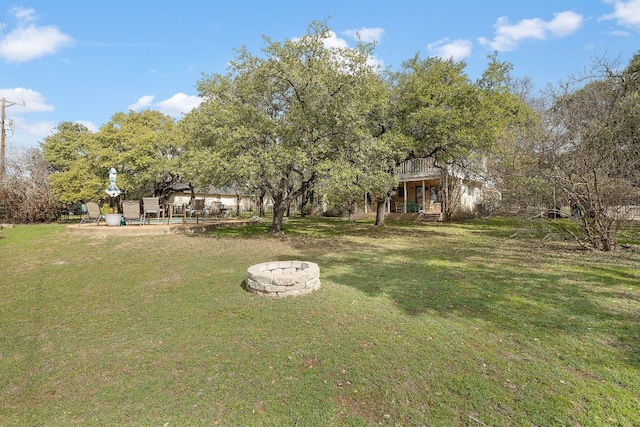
[{"left": 0, "top": 7, "right": 73, "bottom": 62}]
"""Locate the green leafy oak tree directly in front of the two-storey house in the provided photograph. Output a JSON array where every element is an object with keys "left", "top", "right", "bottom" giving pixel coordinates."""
[{"left": 393, "top": 54, "right": 530, "bottom": 218}]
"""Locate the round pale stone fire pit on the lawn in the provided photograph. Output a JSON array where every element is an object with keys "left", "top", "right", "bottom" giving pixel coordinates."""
[{"left": 246, "top": 261, "right": 320, "bottom": 297}]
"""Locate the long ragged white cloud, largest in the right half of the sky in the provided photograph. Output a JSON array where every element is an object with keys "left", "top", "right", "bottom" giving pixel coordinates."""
[{"left": 478, "top": 11, "right": 584, "bottom": 51}]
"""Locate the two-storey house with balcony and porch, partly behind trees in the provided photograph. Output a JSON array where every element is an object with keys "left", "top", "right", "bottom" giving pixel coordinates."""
[{"left": 387, "top": 158, "right": 499, "bottom": 220}]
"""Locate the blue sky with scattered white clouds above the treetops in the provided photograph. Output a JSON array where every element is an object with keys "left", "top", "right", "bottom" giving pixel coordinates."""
[{"left": 0, "top": 0, "right": 640, "bottom": 153}]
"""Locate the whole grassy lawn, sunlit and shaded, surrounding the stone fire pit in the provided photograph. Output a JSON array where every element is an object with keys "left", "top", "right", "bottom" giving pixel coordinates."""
[{"left": 0, "top": 219, "right": 640, "bottom": 427}]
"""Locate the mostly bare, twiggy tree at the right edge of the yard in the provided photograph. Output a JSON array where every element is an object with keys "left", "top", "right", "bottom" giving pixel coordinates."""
[{"left": 538, "top": 55, "right": 640, "bottom": 251}]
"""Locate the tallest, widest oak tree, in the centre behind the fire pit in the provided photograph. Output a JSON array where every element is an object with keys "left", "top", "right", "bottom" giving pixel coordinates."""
[{"left": 182, "top": 22, "right": 388, "bottom": 232}]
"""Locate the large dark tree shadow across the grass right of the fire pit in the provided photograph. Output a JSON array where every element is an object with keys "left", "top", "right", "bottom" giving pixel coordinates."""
[{"left": 202, "top": 219, "right": 640, "bottom": 366}]
